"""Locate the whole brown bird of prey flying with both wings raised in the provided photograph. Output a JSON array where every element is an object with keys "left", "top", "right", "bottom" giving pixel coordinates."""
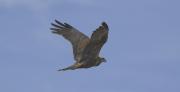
[{"left": 50, "top": 20, "right": 109, "bottom": 71}]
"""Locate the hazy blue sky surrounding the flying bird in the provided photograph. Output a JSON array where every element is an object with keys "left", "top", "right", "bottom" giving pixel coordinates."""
[{"left": 0, "top": 0, "right": 180, "bottom": 92}]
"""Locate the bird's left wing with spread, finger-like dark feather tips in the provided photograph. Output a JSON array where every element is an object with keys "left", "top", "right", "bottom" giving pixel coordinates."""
[{"left": 51, "top": 20, "right": 90, "bottom": 62}]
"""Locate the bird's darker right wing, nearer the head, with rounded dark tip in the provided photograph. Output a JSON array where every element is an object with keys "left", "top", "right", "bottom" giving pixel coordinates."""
[{"left": 83, "top": 22, "right": 109, "bottom": 61}]
